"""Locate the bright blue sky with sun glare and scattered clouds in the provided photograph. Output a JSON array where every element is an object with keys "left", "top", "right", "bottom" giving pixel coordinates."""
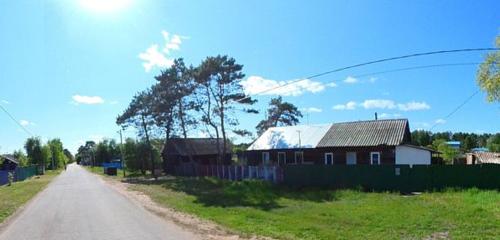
[{"left": 0, "top": 0, "right": 500, "bottom": 152}]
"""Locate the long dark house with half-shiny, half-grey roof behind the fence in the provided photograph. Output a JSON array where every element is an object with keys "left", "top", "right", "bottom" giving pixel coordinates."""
[{"left": 246, "top": 119, "right": 433, "bottom": 165}]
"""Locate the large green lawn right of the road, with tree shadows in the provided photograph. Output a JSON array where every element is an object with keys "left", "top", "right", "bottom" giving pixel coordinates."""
[{"left": 126, "top": 178, "right": 500, "bottom": 239}]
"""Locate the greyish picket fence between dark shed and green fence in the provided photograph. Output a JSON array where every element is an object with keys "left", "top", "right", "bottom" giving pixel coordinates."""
[{"left": 174, "top": 164, "right": 283, "bottom": 182}]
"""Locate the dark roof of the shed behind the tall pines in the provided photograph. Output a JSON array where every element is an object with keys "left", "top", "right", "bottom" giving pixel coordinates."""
[{"left": 163, "top": 138, "right": 231, "bottom": 156}]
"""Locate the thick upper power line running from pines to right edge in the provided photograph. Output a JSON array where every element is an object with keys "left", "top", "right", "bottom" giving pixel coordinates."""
[{"left": 236, "top": 48, "right": 500, "bottom": 102}]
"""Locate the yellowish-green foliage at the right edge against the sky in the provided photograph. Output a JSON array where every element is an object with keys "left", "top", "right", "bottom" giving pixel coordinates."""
[{"left": 477, "top": 36, "right": 500, "bottom": 102}]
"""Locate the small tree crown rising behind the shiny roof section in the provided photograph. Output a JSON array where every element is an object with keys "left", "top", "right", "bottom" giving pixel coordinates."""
[{"left": 256, "top": 96, "right": 302, "bottom": 135}]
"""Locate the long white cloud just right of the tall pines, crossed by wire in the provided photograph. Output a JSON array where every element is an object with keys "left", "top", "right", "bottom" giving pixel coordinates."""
[{"left": 240, "top": 76, "right": 325, "bottom": 96}]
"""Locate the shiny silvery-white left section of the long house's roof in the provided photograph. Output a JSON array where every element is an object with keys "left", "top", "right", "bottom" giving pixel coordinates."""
[{"left": 247, "top": 124, "right": 332, "bottom": 151}]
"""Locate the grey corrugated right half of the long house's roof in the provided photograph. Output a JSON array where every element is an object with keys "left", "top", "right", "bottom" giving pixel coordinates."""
[{"left": 318, "top": 119, "right": 410, "bottom": 147}]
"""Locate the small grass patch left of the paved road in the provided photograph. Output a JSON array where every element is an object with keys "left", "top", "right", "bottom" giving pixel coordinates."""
[{"left": 0, "top": 171, "right": 60, "bottom": 223}]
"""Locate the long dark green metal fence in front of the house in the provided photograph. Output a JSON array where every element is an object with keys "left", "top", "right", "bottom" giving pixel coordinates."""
[{"left": 283, "top": 164, "right": 500, "bottom": 192}]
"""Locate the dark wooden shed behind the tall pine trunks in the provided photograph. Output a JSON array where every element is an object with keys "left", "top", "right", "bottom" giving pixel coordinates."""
[{"left": 162, "top": 138, "right": 232, "bottom": 167}]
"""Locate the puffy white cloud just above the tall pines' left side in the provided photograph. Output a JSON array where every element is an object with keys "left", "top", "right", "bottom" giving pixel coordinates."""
[{"left": 139, "top": 30, "right": 186, "bottom": 72}]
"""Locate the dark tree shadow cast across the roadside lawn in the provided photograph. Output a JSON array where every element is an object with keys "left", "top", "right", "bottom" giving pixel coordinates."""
[{"left": 125, "top": 177, "right": 344, "bottom": 211}]
